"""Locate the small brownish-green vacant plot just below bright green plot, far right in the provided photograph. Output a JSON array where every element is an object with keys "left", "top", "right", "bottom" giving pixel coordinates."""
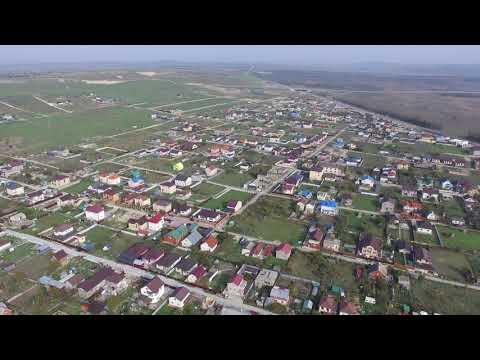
[{"left": 431, "top": 247, "right": 472, "bottom": 282}]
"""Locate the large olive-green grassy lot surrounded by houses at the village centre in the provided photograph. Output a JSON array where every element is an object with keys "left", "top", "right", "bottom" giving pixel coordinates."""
[{"left": 231, "top": 197, "right": 306, "bottom": 245}]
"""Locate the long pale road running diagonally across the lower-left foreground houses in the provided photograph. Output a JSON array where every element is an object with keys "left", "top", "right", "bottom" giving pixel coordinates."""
[{"left": 5, "top": 230, "right": 276, "bottom": 315}]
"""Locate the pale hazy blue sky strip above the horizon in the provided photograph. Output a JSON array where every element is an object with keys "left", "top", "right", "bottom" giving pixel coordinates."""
[{"left": 0, "top": 45, "right": 480, "bottom": 65}]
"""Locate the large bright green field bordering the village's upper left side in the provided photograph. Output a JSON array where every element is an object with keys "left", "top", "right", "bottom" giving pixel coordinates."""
[{"left": 0, "top": 107, "right": 154, "bottom": 152}]
